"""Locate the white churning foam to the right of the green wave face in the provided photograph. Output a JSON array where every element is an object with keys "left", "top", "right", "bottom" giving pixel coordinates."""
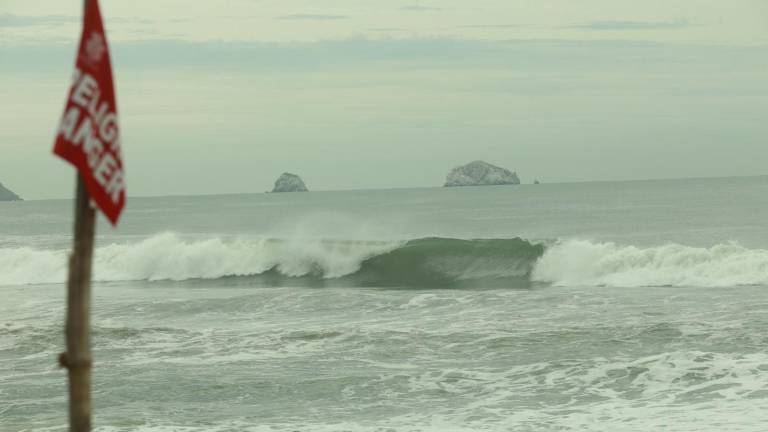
[{"left": 532, "top": 240, "right": 768, "bottom": 287}]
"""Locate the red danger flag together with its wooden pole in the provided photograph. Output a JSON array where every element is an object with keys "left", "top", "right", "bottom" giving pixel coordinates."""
[{"left": 53, "top": 0, "right": 125, "bottom": 424}]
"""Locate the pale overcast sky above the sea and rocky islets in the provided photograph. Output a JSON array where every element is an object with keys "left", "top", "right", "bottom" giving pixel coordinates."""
[{"left": 0, "top": 0, "right": 768, "bottom": 199}]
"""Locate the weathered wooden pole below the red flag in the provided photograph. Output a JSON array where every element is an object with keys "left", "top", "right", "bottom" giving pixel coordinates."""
[{"left": 59, "top": 174, "right": 96, "bottom": 432}]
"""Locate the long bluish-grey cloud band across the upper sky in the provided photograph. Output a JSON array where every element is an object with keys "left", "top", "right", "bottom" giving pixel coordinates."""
[{"left": 0, "top": 38, "right": 768, "bottom": 82}]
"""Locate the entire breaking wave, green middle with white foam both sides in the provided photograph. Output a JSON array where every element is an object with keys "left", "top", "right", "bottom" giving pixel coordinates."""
[{"left": 0, "top": 233, "right": 768, "bottom": 288}]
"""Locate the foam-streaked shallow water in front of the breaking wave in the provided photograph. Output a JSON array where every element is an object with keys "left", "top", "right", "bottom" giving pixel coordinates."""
[{"left": 0, "top": 282, "right": 768, "bottom": 431}]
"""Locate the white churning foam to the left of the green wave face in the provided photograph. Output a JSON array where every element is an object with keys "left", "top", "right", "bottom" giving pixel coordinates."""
[{"left": 0, "top": 233, "right": 399, "bottom": 285}]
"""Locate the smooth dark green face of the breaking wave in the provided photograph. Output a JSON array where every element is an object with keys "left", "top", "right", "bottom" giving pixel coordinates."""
[{"left": 187, "top": 237, "right": 546, "bottom": 289}]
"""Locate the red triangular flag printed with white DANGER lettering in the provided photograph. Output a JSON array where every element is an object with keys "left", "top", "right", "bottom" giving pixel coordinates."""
[{"left": 53, "top": 0, "right": 125, "bottom": 225}]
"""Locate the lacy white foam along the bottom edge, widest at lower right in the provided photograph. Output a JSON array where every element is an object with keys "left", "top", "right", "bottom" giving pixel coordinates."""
[{"left": 90, "top": 351, "right": 768, "bottom": 432}]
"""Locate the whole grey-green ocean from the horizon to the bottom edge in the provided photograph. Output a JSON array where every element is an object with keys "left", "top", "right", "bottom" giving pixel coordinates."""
[{"left": 0, "top": 177, "right": 768, "bottom": 432}]
